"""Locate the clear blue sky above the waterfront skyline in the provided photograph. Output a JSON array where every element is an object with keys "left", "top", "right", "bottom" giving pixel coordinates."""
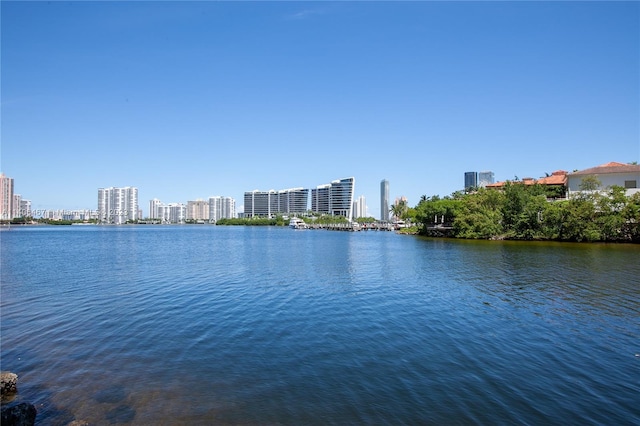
[{"left": 1, "top": 1, "right": 640, "bottom": 217}]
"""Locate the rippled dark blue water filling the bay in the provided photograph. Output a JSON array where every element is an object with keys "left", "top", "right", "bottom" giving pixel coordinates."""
[{"left": 0, "top": 225, "right": 640, "bottom": 425}]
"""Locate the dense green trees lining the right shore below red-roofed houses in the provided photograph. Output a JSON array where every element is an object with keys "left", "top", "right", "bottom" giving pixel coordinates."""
[{"left": 415, "top": 178, "right": 640, "bottom": 243}]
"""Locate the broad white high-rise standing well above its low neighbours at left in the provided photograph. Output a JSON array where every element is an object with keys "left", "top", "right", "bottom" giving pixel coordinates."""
[{"left": 98, "top": 186, "right": 138, "bottom": 225}]
